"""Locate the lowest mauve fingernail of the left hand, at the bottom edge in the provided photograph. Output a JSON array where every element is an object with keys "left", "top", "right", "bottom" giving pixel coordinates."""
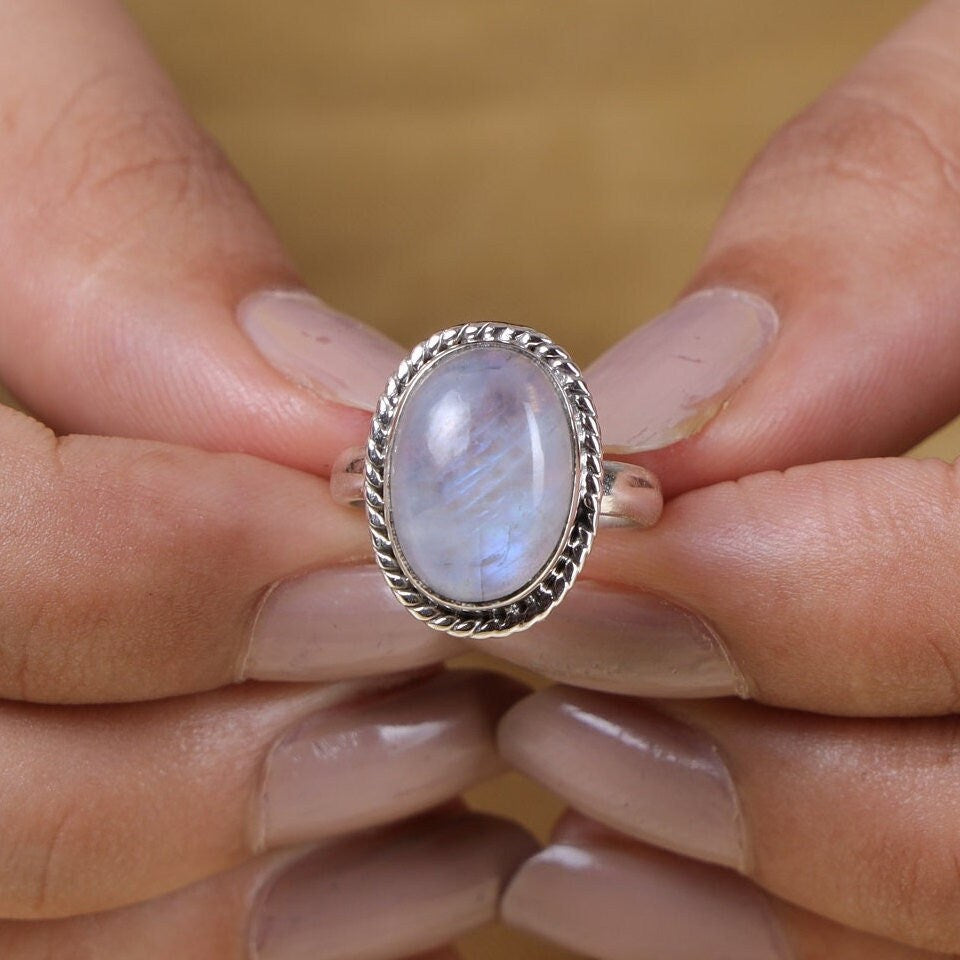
[{"left": 250, "top": 813, "right": 536, "bottom": 960}]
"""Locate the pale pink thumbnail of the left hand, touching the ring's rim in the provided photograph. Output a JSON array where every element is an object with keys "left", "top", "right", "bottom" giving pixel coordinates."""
[{"left": 237, "top": 290, "right": 404, "bottom": 410}]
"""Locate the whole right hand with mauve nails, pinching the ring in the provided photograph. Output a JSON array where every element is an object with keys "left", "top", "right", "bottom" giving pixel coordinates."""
[{"left": 485, "top": 0, "right": 960, "bottom": 960}]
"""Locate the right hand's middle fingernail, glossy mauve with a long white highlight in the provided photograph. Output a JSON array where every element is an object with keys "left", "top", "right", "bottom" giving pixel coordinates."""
[{"left": 499, "top": 687, "right": 744, "bottom": 869}]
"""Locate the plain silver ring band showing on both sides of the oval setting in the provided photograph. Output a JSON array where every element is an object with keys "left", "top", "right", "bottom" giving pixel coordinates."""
[{"left": 330, "top": 447, "right": 663, "bottom": 529}]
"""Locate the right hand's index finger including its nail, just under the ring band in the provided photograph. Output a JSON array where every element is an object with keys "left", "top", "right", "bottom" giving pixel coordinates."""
[{"left": 496, "top": 459, "right": 960, "bottom": 716}]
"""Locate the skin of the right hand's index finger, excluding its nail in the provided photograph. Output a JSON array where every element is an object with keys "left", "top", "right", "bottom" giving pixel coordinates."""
[{"left": 591, "top": 459, "right": 960, "bottom": 715}]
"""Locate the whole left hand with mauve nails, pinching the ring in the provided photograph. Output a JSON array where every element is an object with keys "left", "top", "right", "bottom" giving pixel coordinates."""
[{"left": 0, "top": 0, "right": 532, "bottom": 960}]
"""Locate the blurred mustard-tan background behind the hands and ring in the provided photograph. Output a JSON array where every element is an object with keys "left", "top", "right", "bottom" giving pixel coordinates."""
[{"left": 112, "top": 0, "right": 960, "bottom": 960}]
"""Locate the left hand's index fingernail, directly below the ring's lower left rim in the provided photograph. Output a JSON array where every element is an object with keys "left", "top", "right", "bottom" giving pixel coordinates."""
[{"left": 241, "top": 564, "right": 463, "bottom": 680}]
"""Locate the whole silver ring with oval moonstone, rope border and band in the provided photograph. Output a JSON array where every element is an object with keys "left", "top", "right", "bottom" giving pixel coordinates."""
[{"left": 331, "top": 323, "right": 663, "bottom": 636}]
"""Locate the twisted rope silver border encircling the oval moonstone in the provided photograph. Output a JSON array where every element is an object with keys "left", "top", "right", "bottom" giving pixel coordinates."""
[{"left": 364, "top": 323, "right": 603, "bottom": 637}]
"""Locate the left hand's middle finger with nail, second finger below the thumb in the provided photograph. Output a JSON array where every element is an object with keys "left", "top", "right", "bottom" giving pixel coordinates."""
[{"left": 0, "top": 671, "right": 520, "bottom": 918}]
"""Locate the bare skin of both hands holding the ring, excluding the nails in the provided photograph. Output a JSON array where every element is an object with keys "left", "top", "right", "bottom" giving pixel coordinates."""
[{"left": 0, "top": 0, "right": 960, "bottom": 960}]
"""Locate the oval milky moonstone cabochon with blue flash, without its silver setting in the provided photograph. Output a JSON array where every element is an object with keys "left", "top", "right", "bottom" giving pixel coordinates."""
[{"left": 388, "top": 344, "right": 575, "bottom": 603}]
